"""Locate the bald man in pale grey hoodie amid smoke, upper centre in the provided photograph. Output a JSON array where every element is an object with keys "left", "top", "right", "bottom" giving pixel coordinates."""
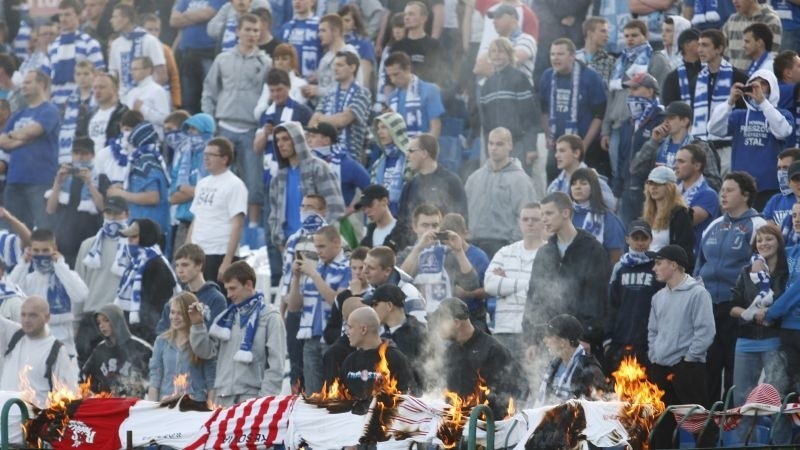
[{"left": 464, "top": 127, "right": 537, "bottom": 259}]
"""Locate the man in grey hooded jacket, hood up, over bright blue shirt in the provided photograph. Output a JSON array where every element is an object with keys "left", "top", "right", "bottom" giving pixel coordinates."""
[{"left": 269, "top": 122, "right": 344, "bottom": 245}]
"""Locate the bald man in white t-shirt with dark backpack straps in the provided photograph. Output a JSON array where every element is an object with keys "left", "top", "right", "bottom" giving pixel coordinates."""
[{"left": 0, "top": 296, "right": 78, "bottom": 407}]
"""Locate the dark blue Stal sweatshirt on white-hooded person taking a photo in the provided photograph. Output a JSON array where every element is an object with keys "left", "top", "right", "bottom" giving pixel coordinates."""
[{"left": 728, "top": 109, "right": 794, "bottom": 192}]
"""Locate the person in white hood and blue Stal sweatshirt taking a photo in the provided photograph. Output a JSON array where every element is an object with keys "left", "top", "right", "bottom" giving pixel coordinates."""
[{"left": 708, "top": 69, "right": 794, "bottom": 193}]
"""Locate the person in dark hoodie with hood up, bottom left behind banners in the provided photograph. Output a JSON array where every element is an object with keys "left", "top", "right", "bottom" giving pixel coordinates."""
[{"left": 81, "top": 304, "right": 153, "bottom": 398}]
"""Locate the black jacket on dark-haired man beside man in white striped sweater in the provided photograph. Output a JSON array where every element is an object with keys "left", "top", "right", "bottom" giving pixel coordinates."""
[{"left": 522, "top": 230, "right": 611, "bottom": 345}]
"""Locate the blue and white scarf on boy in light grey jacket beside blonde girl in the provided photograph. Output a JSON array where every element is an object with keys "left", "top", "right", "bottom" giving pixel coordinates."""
[{"left": 208, "top": 292, "right": 266, "bottom": 364}]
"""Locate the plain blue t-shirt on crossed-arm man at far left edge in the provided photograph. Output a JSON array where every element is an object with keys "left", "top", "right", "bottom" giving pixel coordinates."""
[{"left": 5, "top": 102, "right": 59, "bottom": 185}]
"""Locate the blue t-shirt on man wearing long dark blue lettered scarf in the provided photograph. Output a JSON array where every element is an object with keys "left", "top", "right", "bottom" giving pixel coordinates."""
[{"left": 536, "top": 65, "right": 607, "bottom": 138}]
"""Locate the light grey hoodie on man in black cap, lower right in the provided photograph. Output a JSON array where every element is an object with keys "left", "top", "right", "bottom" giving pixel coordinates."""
[{"left": 647, "top": 275, "right": 716, "bottom": 366}]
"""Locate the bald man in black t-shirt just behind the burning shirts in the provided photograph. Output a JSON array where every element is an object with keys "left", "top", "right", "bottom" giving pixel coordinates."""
[{"left": 341, "top": 306, "right": 416, "bottom": 400}]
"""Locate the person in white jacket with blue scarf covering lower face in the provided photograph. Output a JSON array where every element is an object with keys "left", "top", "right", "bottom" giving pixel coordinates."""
[{"left": 9, "top": 228, "right": 89, "bottom": 356}]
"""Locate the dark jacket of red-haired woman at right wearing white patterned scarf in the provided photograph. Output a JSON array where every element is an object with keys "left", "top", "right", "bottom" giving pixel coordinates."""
[{"left": 730, "top": 265, "right": 789, "bottom": 339}]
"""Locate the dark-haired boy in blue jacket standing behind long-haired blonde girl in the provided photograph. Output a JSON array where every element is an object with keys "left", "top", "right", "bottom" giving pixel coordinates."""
[{"left": 156, "top": 244, "right": 227, "bottom": 334}]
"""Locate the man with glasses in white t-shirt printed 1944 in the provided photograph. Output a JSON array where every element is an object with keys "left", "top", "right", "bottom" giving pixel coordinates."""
[{"left": 186, "top": 137, "right": 247, "bottom": 281}]
